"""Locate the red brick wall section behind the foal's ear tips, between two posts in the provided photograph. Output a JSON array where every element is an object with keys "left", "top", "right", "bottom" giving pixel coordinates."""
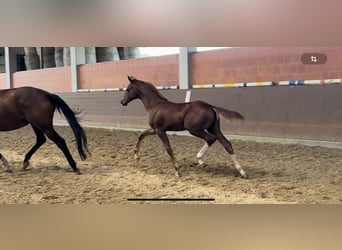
[{"left": 79, "top": 55, "right": 179, "bottom": 89}]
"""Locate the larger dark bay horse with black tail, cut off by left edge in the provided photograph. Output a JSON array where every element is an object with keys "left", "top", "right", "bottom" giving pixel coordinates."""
[{"left": 0, "top": 87, "right": 89, "bottom": 174}]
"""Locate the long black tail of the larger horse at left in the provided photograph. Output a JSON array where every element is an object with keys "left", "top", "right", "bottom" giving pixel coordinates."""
[{"left": 50, "top": 94, "right": 89, "bottom": 160}]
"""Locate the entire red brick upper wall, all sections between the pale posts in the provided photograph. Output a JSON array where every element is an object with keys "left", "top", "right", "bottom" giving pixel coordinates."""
[{"left": 4, "top": 47, "right": 342, "bottom": 92}]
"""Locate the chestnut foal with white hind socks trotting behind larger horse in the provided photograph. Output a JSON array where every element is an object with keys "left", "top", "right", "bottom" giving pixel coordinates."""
[{"left": 121, "top": 76, "right": 247, "bottom": 178}]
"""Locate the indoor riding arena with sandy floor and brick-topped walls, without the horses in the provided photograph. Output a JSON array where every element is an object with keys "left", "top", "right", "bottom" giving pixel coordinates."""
[{"left": 0, "top": 47, "right": 342, "bottom": 204}]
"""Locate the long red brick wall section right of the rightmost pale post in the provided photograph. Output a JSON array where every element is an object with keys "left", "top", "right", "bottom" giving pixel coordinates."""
[{"left": 192, "top": 47, "right": 342, "bottom": 84}]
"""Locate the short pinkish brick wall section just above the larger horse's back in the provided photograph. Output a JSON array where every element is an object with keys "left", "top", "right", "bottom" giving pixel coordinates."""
[{"left": 13, "top": 67, "right": 72, "bottom": 92}]
